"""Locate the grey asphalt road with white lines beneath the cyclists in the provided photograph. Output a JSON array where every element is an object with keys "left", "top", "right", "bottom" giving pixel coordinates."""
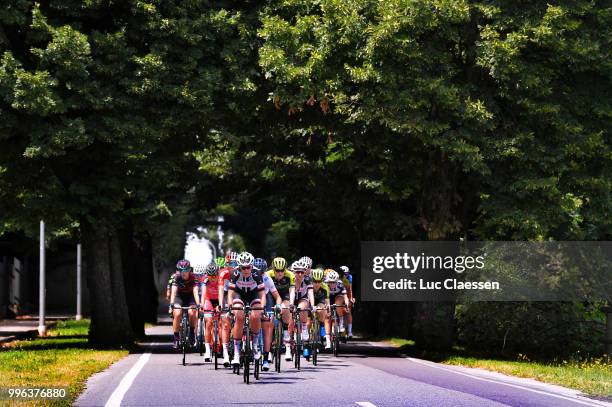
[{"left": 76, "top": 325, "right": 612, "bottom": 407}]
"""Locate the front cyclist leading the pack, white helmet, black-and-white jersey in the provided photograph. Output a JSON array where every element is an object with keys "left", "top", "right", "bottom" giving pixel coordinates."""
[{"left": 227, "top": 252, "right": 265, "bottom": 366}]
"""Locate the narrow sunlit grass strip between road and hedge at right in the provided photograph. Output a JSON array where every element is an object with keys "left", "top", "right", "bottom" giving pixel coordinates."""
[{"left": 385, "top": 338, "right": 612, "bottom": 399}]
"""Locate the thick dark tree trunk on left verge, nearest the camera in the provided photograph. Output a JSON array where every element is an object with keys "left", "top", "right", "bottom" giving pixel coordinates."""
[{"left": 81, "top": 222, "right": 134, "bottom": 346}]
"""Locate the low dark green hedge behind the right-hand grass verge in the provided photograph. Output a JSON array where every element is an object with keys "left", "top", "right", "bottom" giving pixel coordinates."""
[{"left": 456, "top": 302, "right": 605, "bottom": 360}]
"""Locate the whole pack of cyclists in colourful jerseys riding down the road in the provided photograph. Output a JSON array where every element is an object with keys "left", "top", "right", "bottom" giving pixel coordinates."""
[{"left": 166, "top": 251, "right": 355, "bottom": 371}]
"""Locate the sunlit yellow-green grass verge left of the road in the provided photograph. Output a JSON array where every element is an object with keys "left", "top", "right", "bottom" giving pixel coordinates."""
[{"left": 0, "top": 319, "right": 128, "bottom": 406}]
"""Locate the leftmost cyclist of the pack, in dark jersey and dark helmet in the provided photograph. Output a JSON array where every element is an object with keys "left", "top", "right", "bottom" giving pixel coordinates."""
[{"left": 170, "top": 259, "right": 200, "bottom": 349}]
